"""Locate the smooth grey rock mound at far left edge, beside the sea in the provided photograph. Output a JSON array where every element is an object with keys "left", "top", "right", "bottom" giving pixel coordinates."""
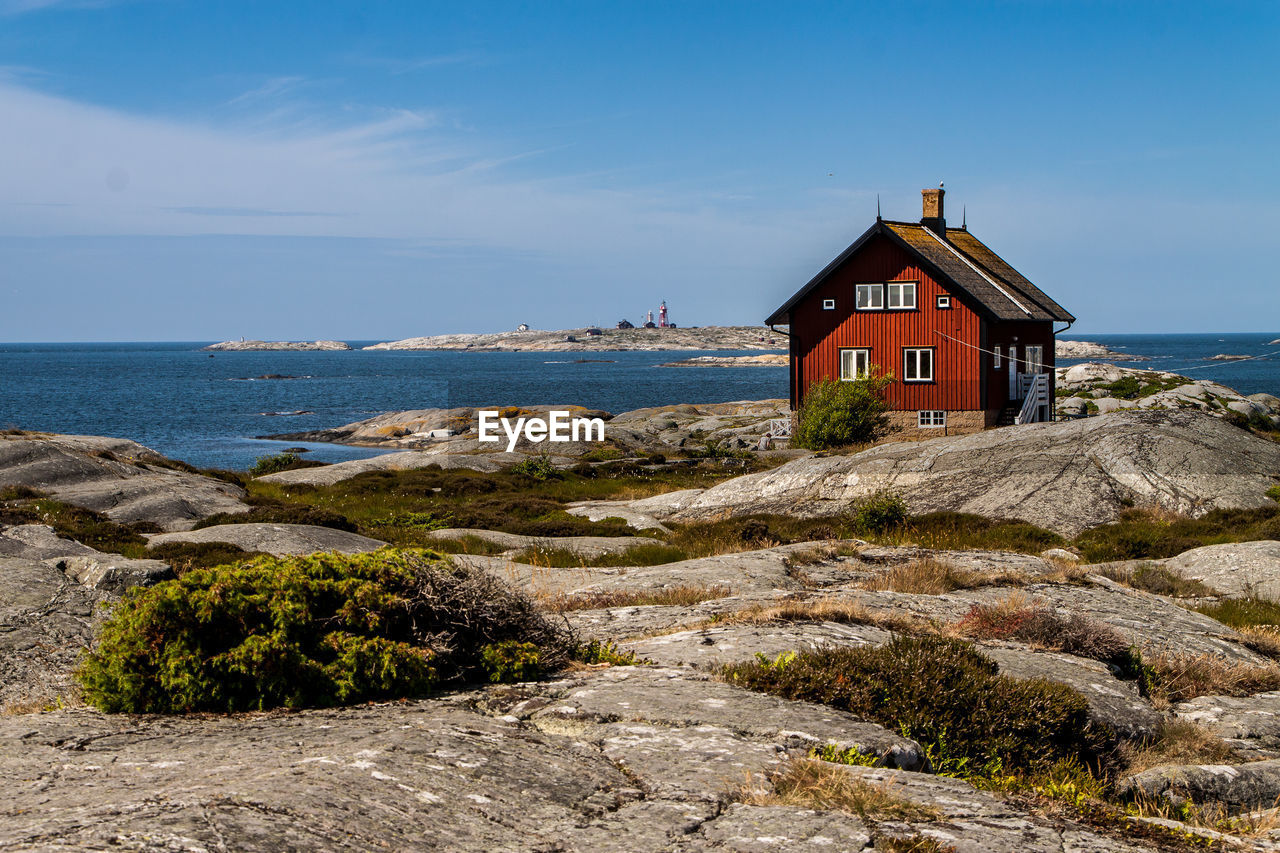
[{"left": 0, "top": 433, "right": 248, "bottom": 530}]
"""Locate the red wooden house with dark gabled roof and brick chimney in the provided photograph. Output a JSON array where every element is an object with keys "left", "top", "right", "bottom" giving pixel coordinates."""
[{"left": 765, "top": 188, "right": 1075, "bottom": 435}]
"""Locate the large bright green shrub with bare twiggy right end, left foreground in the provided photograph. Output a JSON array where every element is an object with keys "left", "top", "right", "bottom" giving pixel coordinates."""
[{"left": 78, "top": 551, "right": 572, "bottom": 713}]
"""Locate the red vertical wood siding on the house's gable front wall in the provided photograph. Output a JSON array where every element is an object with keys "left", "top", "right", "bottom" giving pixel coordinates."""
[{"left": 791, "top": 236, "right": 983, "bottom": 411}]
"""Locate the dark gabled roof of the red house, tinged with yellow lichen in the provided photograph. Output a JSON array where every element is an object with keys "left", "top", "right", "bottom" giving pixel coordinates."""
[{"left": 765, "top": 219, "right": 1075, "bottom": 325}]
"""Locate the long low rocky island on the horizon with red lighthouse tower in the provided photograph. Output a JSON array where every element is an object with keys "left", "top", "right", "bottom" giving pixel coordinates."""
[{"left": 365, "top": 325, "right": 787, "bottom": 352}]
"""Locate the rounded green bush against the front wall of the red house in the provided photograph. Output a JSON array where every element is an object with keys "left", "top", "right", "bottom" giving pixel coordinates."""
[{"left": 791, "top": 375, "right": 893, "bottom": 450}]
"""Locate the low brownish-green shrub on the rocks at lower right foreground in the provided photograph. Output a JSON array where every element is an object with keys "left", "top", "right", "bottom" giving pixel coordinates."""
[{"left": 723, "top": 637, "right": 1114, "bottom": 776}]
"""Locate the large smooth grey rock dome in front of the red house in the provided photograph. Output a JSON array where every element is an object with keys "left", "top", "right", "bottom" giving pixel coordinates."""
[{"left": 583, "top": 410, "right": 1280, "bottom": 535}]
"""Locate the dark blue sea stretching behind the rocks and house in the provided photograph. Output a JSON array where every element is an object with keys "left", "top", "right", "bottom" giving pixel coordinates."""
[{"left": 0, "top": 333, "right": 1280, "bottom": 470}]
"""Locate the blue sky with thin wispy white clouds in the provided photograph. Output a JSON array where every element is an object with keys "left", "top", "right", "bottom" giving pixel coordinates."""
[{"left": 0, "top": 0, "right": 1280, "bottom": 341}]
